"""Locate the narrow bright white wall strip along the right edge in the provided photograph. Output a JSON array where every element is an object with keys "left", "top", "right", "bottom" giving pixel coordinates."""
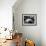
[{"left": 41, "top": 0, "right": 46, "bottom": 46}]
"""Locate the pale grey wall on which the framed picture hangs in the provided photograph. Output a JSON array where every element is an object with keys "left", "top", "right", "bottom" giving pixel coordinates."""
[{"left": 13, "top": 0, "right": 41, "bottom": 46}]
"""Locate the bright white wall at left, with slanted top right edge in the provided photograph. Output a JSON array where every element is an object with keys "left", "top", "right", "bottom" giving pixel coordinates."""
[{"left": 0, "top": 0, "right": 16, "bottom": 29}]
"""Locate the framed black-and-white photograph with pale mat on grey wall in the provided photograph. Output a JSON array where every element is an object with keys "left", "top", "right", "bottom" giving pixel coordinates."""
[{"left": 22, "top": 14, "right": 37, "bottom": 26}]
